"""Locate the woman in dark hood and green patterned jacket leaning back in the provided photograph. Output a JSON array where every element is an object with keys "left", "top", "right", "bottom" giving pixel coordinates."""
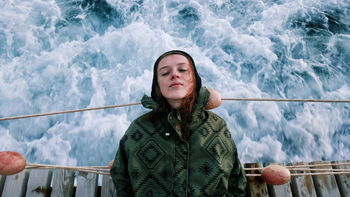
[{"left": 111, "top": 50, "right": 246, "bottom": 197}]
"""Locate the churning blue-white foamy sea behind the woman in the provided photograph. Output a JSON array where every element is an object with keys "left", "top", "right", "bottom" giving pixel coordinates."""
[{"left": 0, "top": 0, "right": 350, "bottom": 165}]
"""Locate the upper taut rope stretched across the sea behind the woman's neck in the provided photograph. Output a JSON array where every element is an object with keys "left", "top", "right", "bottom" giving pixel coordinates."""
[{"left": 0, "top": 98, "right": 350, "bottom": 121}]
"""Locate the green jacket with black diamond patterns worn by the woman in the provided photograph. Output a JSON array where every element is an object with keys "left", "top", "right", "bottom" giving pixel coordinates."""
[{"left": 110, "top": 88, "right": 246, "bottom": 197}]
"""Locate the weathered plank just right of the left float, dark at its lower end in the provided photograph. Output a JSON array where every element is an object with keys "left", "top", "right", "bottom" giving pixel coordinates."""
[{"left": 26, "top": 169, "right": 52, "bottom": 197}]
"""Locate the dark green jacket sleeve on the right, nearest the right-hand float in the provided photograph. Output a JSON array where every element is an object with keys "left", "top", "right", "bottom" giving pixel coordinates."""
[{"left": 228, "top": 141, "right": 247, "bottom": 197}]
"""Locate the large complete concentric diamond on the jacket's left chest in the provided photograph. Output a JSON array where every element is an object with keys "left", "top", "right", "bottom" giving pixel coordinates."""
[{"left": 137, "top": 140, "right": 165, "bottom": 169}]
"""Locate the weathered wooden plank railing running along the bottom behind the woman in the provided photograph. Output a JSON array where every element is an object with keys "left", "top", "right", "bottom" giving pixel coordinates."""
[{"left": 0, "top": 161, "right": 350, "bottom": 197}]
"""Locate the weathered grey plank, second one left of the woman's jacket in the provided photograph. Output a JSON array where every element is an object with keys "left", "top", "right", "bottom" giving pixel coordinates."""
[{"left": 76, "top": 172, "right": 97, "bottom": 197}]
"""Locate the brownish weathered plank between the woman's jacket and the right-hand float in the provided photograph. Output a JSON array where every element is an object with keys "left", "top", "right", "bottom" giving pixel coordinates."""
[{"left": 244, "top": 163, "right": 269, "bottom": 197}]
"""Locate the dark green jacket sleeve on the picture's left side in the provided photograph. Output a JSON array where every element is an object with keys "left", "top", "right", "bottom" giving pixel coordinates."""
[{"left": 110, "top": 135, "right": 134, "bottom": 197}]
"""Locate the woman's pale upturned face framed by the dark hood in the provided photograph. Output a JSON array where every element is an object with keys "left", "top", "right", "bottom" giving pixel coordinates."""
[{"left": 157, "top": 54, "right": 195, "bottom": 102}]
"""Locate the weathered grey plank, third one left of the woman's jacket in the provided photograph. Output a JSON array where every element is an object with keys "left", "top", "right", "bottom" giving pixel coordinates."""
[{"left": 51, "top": 170, "right": 74, "bottom": 197}]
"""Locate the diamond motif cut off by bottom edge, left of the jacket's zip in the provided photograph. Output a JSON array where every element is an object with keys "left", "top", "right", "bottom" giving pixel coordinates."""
[{"left": 135, "top": 175, "right": 170, "bottom": 197}]
